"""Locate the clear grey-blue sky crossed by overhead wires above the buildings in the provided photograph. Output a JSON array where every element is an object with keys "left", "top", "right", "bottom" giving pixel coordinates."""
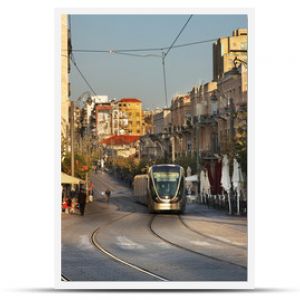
[{"left": 69, "top": 14, "right": 247, "bottom": 109}]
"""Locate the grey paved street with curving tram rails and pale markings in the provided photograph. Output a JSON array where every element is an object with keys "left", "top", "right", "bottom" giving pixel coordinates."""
[{"left": 62, "top": 173, "right": 247, "bottom": 281}]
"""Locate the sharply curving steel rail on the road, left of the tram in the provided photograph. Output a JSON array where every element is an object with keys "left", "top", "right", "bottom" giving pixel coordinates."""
[{"left": 91, "top": 213, "right": 169, "bottom": 281}]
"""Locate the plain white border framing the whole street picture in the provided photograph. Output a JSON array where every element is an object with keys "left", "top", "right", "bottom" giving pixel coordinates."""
[{"left": 54, "top": 8, "right": 254, "bottom": 290}]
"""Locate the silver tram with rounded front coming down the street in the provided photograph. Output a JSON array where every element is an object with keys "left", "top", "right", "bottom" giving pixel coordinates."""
[{"left": 133, "top": 164, "right": 186, "bottom": 213}]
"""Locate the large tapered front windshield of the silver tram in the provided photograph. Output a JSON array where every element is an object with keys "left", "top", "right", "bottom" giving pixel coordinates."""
[{"left": 152, "top": 166, "right": 180, "bottom": 198}]
